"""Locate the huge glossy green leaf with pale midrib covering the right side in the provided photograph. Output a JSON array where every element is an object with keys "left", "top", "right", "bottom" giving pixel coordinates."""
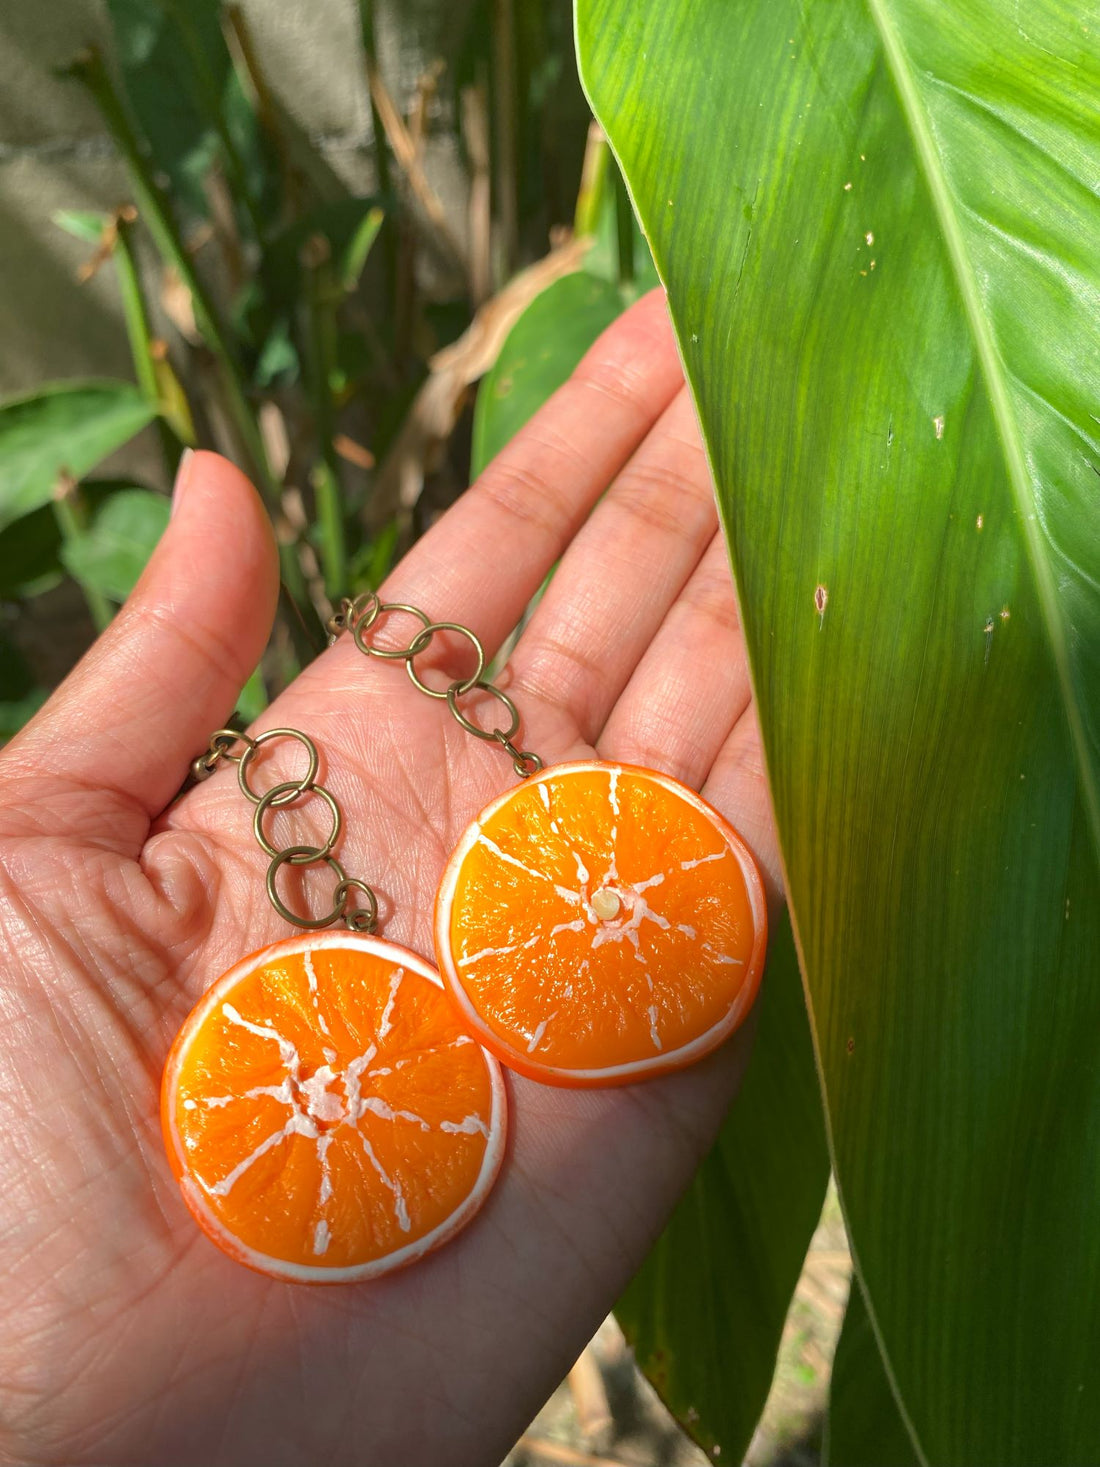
[{"left": 578, "top": 0, "right": 1100, "bottom": 1467}]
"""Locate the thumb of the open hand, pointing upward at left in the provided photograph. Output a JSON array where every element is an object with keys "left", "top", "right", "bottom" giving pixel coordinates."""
[{"left": 1, "top": 453, "right": 279, "bottom": 849}]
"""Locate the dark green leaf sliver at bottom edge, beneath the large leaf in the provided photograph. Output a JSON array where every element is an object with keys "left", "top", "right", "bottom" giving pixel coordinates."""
[{"left": 821, "top": 1278, "right": 918, "bottom": 1467}]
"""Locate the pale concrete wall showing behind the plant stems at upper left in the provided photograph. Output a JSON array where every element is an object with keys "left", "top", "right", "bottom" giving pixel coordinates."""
[{"left": 0, "top": 0, "right": 469, "bottom": 395}]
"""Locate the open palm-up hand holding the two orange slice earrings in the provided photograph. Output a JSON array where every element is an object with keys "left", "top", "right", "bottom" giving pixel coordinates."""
[{"left": 0, "top": 295, "right": 779, "bottom": 1467}]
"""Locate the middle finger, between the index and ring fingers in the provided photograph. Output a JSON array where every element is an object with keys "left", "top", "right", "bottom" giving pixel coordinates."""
[{"left": 510, "top": 389, "right": 717, "bottom": 742}]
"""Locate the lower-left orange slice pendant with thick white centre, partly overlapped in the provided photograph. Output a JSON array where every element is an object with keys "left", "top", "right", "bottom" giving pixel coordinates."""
[{"left": 161, "top": 932, "right": 505, "bottom": 1284}]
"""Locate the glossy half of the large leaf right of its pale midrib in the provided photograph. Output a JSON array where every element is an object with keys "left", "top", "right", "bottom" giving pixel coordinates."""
[{"left": 868, "top": 0, "right": 1100, "bottom": 852}]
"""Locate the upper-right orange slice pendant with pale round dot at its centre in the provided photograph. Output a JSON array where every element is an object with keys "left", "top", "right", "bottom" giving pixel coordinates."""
[{"left": 436, "top": 763, "right": 767, "bottom": 1086}]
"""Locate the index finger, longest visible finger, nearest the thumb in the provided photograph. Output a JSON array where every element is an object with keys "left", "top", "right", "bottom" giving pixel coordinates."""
[{"left": 353, "top": 290, "right": 683, "bottom": 667}]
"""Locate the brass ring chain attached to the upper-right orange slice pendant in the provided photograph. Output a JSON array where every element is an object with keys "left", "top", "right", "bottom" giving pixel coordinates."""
[{"left": 329, "top": 591, "right": 543, "bottom": 779}]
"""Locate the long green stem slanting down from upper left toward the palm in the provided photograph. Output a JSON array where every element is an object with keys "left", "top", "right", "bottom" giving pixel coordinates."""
[{"left": 69, "top": 47, "right": 324, "bottom": 651}]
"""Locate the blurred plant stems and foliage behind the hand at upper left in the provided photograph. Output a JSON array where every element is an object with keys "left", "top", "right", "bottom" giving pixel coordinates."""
[{"left": 0, "top": 0, "right": 637, "bottom": 735}]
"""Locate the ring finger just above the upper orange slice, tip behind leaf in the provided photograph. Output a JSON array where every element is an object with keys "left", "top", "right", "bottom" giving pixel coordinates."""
[{"left": 598, "top": 531, "right": 752, "bottom": 789}]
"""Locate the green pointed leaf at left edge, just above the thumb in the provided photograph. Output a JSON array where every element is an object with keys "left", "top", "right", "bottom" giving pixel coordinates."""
[{"left": 0, "top": 381, "right": 157, "bottom": 528}]
